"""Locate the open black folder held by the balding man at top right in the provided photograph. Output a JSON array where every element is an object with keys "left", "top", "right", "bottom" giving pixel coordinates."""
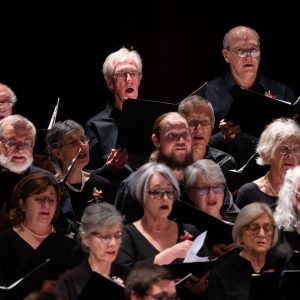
[{"left": 226, "top": 88, "right": 300, "bottom": 137}]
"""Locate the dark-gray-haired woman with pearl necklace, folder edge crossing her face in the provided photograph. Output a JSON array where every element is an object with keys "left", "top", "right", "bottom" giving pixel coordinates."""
[{"left": 46, "top": 120, "right": 113, "bottom": 232}]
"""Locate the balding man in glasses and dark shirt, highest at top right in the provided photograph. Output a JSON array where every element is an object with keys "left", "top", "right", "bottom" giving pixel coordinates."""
[{"left": 196, "top": 26, "right": 295, "bottom": 189}]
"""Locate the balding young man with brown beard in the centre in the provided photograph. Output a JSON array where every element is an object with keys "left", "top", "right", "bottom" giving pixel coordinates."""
[{"left": 115, "top": 112, "right": 193, "bottom": 223}]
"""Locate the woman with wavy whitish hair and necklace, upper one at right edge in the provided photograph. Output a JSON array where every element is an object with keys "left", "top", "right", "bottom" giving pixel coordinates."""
[{"left": 236, "top": 118, "right": 300, "bottom": 210}]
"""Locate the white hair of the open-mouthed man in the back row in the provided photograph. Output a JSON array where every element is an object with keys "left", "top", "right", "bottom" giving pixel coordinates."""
[{"left": 102, "top": 47, "right": 143, "bottom": 81}]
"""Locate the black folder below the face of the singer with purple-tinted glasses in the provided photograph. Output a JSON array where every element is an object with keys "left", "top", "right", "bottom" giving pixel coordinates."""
[{"left": 172, "top": 200, "right": 233, "bottom": 246}]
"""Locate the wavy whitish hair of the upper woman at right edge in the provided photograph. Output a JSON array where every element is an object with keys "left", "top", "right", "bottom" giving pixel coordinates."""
[{"left": 256, "top": 118, "right": 300, "bottom": 165}]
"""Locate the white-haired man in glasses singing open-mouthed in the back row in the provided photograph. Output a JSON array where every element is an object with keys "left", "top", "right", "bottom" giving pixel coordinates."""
[{"left": 85, "top": 47, "right": 145, "bottom": 192}]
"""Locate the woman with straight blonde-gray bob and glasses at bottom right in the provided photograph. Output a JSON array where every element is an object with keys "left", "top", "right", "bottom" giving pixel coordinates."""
[{"left": 207, "top": 203, "right": 278, "bottom": 300}]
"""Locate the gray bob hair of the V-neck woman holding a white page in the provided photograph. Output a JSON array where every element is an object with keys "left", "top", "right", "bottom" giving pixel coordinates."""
[{"left": 130, "top": 162, "right": 180, "bottom": 207}]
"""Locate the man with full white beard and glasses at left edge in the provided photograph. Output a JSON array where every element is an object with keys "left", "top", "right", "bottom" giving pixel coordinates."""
[{"left": 0, "top": 115, "right": 53, "bottom": 230}]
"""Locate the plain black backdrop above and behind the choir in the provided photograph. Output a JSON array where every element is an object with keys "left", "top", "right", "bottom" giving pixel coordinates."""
[{"left": 0, "top": 0, "right": 300, "bottom": 128}]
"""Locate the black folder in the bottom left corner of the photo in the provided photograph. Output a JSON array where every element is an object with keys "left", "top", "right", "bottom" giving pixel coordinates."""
[{"left": 0, "top": 258, "right": 50, "bottom": 300}]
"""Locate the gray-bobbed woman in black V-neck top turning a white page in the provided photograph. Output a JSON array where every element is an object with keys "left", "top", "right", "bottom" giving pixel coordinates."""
[{"left": 117, "top": 162, "right": 199, "bottom": 267}]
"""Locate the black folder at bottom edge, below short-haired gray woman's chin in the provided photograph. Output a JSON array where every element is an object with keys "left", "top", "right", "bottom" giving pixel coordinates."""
[{"left": 78, "top": 272, "right": 125, "bottom": 300}]
